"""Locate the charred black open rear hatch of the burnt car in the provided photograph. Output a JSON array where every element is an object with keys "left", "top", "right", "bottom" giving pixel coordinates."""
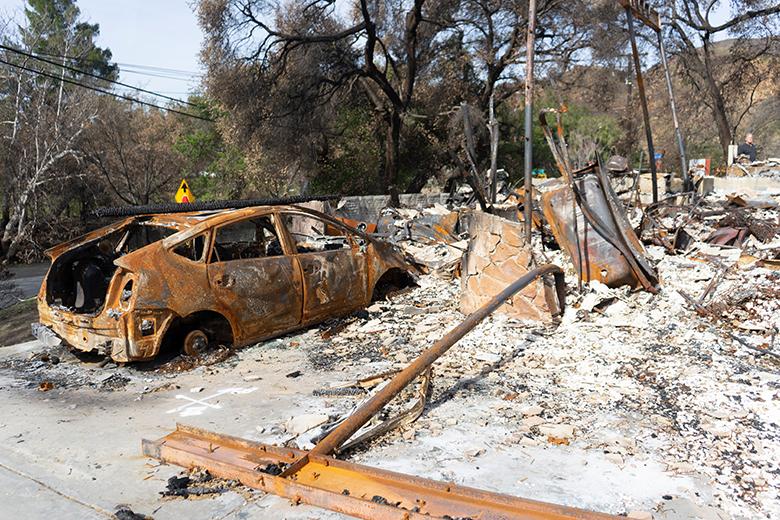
[{"left": 46, "top": 221, "right": 178, "bottom": 314}]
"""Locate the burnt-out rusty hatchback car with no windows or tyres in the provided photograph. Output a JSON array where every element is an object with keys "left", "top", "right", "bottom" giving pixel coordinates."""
[{"left": 34, "top": 206, "right": 414, "bottom": 362}]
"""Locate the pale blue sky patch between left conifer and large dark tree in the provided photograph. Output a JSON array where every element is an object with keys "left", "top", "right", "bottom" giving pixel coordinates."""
[{"left": 0, "top": 0, "right": 202, "bottom": 99}]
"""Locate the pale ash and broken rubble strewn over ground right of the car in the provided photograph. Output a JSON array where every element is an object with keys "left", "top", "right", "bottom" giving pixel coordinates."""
[{"left": 272, "top": 189, "right": 780, "bottom": 518}]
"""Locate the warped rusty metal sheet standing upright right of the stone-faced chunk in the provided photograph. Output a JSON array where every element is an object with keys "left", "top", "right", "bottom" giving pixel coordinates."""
[{"left": 540, "top": 110, "right": 658, "bottom": 292}]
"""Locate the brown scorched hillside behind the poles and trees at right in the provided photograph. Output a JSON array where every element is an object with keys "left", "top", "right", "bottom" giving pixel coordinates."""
[{"left": 547, "top": 40, "right": 780, "bottom": 166}]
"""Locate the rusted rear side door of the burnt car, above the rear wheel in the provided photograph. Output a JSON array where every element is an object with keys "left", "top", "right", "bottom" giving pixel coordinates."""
[{"left": 208, "top": 215, "right": 303, "bottom": 343}]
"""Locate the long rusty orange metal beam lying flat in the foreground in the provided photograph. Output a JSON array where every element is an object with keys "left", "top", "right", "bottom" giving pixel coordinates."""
[{"left": 143, "top": 425, "right": 620, "bottom": 520}]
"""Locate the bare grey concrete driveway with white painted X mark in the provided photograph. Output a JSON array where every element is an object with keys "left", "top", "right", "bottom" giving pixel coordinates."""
[{"left": 0, "top": 342, "right": 350, "bottom": 520}]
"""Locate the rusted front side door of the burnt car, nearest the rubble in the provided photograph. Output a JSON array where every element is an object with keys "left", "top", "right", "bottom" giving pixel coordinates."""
[{"left": 281, "top": 212, "right": 368, "bottom": 323}]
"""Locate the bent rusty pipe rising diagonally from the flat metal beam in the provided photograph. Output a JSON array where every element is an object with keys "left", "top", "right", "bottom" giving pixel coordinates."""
[{"left": 282, "top": 264, "right": 566, "bottom": 477}]
